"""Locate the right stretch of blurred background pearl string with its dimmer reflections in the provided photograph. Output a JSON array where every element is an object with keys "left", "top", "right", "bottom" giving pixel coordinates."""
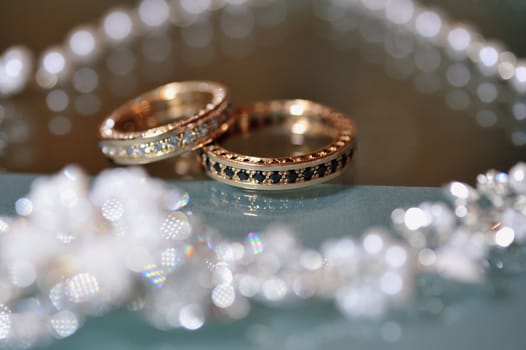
[{"left": 314, "top": 0, "right": 526, "bottom": 146}]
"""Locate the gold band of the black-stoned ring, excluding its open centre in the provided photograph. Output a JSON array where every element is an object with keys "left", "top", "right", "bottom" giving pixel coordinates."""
[{"left": 202, "top": 100, "right": 356, "bottom": 190}]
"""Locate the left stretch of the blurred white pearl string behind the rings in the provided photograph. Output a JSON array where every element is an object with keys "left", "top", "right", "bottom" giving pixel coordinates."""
[{"left": 0, "top": 0, "right": 274, "bottom": 98}]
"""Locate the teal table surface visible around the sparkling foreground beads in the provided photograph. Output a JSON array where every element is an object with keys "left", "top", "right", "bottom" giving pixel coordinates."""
[{"left": 0, "top": 174, "right": 526, "bottom": 350}]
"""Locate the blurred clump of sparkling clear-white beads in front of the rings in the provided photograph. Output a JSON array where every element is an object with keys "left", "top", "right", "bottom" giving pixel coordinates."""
[{"left": 0, "top": 163, "right": 526, "bottom": 347}]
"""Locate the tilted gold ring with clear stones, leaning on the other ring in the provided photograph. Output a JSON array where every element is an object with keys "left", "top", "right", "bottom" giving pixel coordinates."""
[{"left": 99, "top": 81, "right": 230, "bottom": 165}]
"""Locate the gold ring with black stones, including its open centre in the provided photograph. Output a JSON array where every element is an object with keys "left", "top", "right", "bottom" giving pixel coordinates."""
[{"left": 201, "top": 100, "right": 356, "bottom": 190}]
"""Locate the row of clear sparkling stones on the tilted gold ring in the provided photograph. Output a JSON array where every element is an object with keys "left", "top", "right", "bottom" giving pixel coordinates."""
[{"left": 102, "top": 113, "right": 226, "bottom": 159}]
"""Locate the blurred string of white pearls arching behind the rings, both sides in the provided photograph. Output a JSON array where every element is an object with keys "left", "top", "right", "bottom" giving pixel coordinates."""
[{"left": 0, "top": 0, "right": 526, "bottom": 131}]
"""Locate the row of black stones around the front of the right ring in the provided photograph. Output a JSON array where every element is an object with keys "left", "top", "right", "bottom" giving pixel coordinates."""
[{"left": 202, "top": 149, "right": 354, "bottom": 185}]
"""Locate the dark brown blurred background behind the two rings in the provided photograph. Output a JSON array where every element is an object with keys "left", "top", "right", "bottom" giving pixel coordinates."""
[{"left": 0, "top": 0, "right": 526, "bottom": 186}]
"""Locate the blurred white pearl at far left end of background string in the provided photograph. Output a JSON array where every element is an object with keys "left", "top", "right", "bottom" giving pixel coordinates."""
[{"left": 0, "top": 46, "right": 33, "bottom": 96}]
